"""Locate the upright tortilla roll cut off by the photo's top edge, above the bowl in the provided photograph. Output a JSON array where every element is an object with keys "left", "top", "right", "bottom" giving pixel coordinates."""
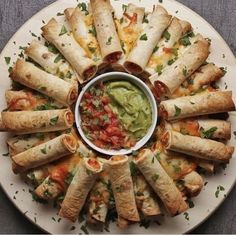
[{"left": 90, "top": 0, "right": 122, "bottom": 63}]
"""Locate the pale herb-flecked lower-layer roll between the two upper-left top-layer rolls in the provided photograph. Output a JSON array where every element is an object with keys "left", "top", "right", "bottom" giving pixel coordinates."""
[{"left": 25, "top": 40, "right": 78, "bottom": 83}]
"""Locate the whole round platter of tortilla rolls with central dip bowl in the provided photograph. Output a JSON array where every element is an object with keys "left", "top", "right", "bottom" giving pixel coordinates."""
[{"left": 0, "top": 0, "right": 236, "bottom": 234}]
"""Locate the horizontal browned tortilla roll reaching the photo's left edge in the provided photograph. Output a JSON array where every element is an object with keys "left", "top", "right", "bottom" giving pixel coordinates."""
[{"left": 2, "top": 109, "right": 74, "bottom": 134}]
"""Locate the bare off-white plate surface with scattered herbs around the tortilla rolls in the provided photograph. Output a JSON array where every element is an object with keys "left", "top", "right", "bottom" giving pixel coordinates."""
[{"left": 0, "top": 0, "right": 236, "bottom": 234}]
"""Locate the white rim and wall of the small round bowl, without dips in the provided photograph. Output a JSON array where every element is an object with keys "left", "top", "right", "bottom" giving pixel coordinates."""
[{"left": 75, "top": 72, "right": 158, "bottom": 156}]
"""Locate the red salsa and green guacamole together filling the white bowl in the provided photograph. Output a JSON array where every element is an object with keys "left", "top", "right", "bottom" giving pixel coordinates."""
[{"left": 80, "top": 81, "right": 152, "bottom": 150}]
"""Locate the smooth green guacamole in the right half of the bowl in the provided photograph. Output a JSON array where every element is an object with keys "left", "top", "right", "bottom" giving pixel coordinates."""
[{"left": 105, "top": 81, "right": 152, "bottom": 140}]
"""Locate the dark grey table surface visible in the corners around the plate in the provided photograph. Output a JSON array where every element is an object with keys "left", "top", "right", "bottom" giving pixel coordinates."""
[{"left": 0, "top": 0, "right": 236, "bottom": 234}]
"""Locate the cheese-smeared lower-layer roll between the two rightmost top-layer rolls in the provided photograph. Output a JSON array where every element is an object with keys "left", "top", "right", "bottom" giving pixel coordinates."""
[{"left": 165, "top": 118, "right": 231, "bottom": 140}]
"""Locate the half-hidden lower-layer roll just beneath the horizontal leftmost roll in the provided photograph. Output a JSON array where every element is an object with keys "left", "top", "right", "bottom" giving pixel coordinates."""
[{"left": 7, "top": 132, "right": 58, "bottom": 156}]
